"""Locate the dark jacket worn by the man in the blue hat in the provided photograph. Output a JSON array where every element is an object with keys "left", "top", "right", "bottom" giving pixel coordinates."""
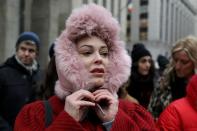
[{"left": 0, "top": 56, "right": 41, "bottom": 127}]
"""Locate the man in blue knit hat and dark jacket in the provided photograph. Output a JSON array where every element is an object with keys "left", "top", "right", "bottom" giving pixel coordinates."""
[{"left": 0, "top": 32, "right": 41, "bottom": 128}]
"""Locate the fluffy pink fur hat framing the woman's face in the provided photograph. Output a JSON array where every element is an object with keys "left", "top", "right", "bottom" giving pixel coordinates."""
[{"left": 55, "top": 4, "right": 131, "bottom": 99}]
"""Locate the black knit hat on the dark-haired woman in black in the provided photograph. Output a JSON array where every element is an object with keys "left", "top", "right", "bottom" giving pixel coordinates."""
[{"left": 131, "top": 43, "right": 151, "bottom": 63}]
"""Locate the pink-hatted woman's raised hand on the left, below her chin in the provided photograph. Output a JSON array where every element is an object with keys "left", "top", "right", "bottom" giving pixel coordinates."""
[{"left": 64, "top": 89, "right": 95, "bottom": 121}]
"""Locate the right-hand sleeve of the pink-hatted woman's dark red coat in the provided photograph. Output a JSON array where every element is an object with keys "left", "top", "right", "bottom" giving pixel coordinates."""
[{"left": 112, "top": 100, "right": 157, "bottom": 131}]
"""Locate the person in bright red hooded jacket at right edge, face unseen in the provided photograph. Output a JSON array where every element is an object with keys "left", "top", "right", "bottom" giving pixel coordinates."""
[{"left": 157, "top": 75, "right": 197, "bottom": 131}]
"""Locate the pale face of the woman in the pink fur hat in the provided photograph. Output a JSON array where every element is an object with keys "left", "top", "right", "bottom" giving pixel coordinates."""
[{"left": 77, "top": 37, "right": 109, "bottom": 87}]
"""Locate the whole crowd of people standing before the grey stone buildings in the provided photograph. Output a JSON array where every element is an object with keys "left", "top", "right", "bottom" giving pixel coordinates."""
[{"left": 0, "top": 4, "right": 197, "bottom": 131}]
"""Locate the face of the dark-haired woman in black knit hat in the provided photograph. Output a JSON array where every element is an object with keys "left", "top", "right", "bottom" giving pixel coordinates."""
[{"left": 138, "top": 56, "right": 152, "bottom": 75}]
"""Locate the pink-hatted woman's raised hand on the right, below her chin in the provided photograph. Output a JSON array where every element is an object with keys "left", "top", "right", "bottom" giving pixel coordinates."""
[{"left": 93, "top": 89, "right": 118, "bottom": 122}]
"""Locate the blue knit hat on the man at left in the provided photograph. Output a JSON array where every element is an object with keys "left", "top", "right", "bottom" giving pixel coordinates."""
[{"left": 16, "top": 32, "right": 40, "bottom": 48}]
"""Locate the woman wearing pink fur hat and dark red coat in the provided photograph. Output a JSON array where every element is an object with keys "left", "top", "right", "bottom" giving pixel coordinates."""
[{"left": 15, "top": 4, "right": 155, "bottom": 131}]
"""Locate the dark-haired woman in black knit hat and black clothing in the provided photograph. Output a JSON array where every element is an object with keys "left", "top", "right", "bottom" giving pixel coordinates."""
[{"left": 127, "top": 43, "right": 155, "bottom": 109}]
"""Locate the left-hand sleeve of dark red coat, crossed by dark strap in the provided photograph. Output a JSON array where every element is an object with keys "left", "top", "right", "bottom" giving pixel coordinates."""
[{"left": 14, "top": 102, "right": 85, "bottom": 131}]
